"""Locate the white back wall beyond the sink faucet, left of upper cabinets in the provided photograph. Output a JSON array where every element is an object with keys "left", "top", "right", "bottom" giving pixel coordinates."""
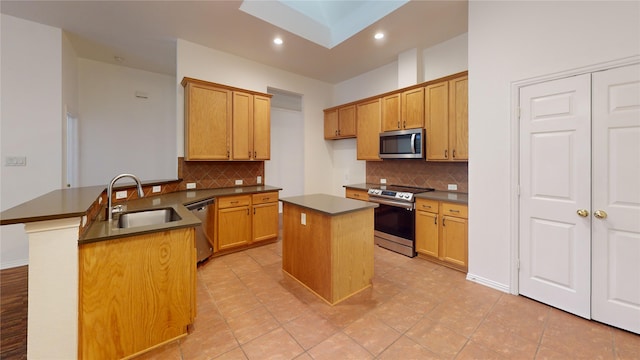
[{"left": 78, "top": 59, "right": 178, "bottom": 186}]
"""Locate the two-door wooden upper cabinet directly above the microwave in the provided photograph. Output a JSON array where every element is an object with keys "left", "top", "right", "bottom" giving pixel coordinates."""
[{"left": 382, "top": 87, "right": 425, "bottom": 131}]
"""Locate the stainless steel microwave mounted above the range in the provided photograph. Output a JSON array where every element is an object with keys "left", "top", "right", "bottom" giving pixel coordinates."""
[{"left": 380, "top": 129, "right": 424, "bottom": 159}]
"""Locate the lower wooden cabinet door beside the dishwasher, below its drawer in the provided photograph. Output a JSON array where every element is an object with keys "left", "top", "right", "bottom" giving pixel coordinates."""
[{"left": 217, "top": 206, "right": 251, "bottom": 250}]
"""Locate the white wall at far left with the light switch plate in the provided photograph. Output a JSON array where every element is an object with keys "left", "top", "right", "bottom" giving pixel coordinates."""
[{"left": 0, "top": 14, "right": 62, "bottom": 268}]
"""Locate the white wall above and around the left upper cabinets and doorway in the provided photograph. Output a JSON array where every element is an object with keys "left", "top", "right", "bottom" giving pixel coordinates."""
[{"left": 176, "top": 39, "right": 336, "bottom": 193}]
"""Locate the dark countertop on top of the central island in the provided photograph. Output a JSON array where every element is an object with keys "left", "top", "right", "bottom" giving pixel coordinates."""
[{"left": 280, "top": 194, "right": 378, "bottom": 216}]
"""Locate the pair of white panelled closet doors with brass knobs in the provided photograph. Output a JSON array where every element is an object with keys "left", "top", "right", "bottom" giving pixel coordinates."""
[{"left": 519, "top": 65, "right": 640, "bottom": 333}]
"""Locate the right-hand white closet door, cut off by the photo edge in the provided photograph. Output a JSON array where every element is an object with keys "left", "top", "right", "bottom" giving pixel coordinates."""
[{"left": 592, "top": 65, "right": 640, "bottom": 333}]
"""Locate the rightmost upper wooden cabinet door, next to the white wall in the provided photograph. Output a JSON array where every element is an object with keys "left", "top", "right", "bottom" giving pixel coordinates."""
[{"left": 449, "top": 76, "right": 469, "bottom": 161}]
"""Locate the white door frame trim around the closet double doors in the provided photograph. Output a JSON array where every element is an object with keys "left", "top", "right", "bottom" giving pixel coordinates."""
[{"left": 509, "top": 55, "right": 640, "bottom": 295}]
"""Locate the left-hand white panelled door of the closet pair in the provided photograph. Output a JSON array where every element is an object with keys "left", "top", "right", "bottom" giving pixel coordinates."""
[{"left": 519, "top": 74, "right": 591, "bottom": 318}]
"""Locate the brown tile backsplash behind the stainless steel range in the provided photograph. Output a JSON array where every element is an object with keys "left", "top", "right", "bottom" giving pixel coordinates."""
[{"left": 366, "top": 159, "right": 469, "bottom": 193}]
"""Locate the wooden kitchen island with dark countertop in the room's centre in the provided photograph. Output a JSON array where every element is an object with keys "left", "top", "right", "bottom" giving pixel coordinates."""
[{"left": 280, "top": 194, "right": 378, "bottom": 305}]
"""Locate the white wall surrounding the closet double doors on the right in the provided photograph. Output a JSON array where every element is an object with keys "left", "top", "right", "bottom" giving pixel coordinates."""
[{"left": 469, "top": 1, "right": 640, "bottom": 289}]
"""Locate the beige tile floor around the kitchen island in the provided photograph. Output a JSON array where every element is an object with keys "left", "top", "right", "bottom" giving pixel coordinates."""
[{"left": 142, "top": 241, "right": 640, "bottom": 360}]
